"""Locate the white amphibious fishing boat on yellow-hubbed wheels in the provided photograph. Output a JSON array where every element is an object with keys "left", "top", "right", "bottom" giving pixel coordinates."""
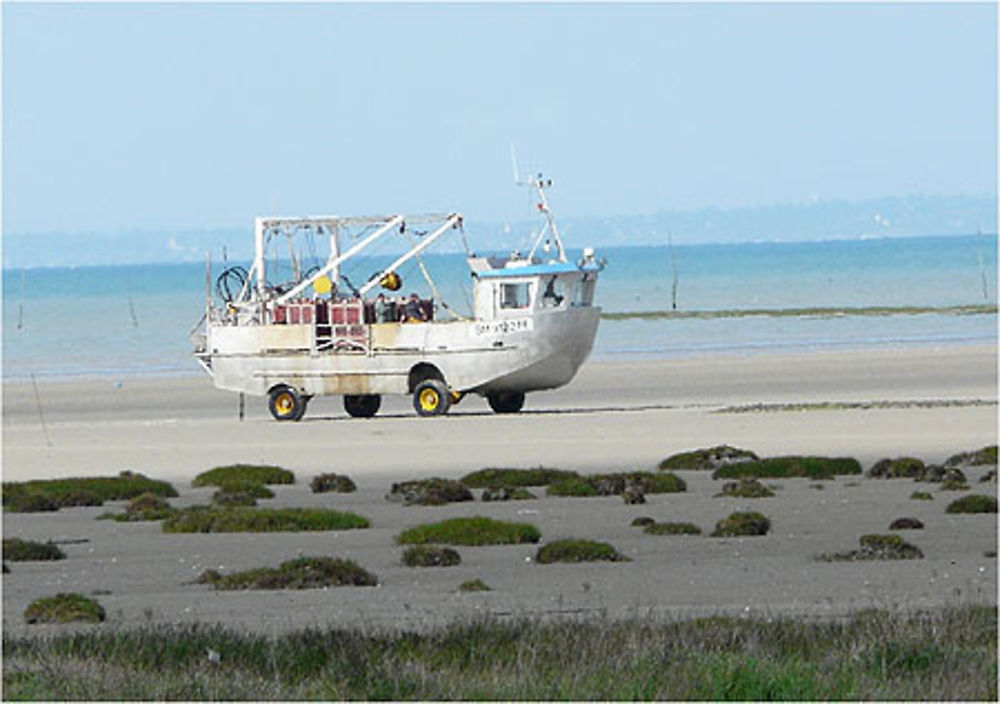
[{"left": 192, "top": 174, "right": 604, "bottom": 421}]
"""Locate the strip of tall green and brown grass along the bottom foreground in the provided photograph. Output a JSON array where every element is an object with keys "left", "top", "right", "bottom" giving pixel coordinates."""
[{"left": 3, "top": 606, "right": 997, "bottom": 701}]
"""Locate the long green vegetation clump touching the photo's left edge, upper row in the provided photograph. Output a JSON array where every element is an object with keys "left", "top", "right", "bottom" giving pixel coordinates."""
[{"left": 3, "top": 471, "right": 177, "bottom": 512}]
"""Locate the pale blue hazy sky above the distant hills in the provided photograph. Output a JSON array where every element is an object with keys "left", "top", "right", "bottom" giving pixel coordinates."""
[{"left": 3, "top": 2, "right": 997, "bottom": 239}]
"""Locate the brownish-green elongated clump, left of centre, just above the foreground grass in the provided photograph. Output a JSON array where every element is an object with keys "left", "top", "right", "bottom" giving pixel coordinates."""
[{"left": 198, "top": 557, "right": 378, "bottom": 590}]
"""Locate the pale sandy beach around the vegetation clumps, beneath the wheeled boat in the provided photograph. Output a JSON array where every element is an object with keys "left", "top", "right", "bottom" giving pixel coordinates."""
[{"left": 3, "top": 345, "right": 997, "bottom": 632}]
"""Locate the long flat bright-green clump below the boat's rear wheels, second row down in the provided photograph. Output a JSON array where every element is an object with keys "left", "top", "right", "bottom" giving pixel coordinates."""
[{"left": 163, "top": 506, "right": 371, "bottom": 533}]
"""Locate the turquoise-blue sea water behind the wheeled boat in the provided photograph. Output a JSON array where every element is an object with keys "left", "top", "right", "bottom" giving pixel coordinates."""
[{"left": 3, "top": 235, "right": 997, "bottom": 380}]
